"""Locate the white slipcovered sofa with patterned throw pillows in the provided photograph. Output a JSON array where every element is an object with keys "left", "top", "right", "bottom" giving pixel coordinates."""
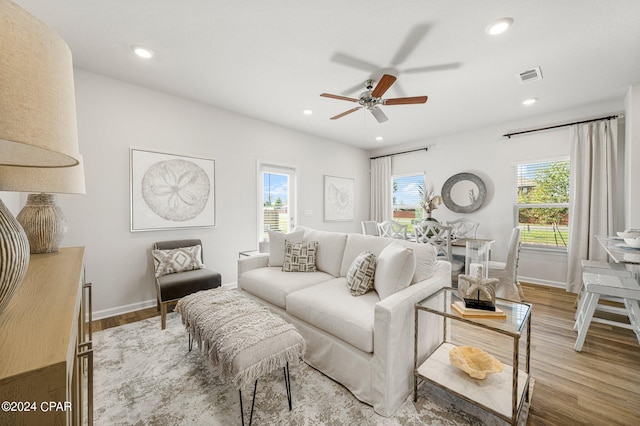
[{"left": 238, "top": 227, "right": 451, "bottom": 416}]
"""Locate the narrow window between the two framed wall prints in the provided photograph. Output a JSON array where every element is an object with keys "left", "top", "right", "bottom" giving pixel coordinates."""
[{"left": 258, "top": 163, "right": 296, "bottom": 241}]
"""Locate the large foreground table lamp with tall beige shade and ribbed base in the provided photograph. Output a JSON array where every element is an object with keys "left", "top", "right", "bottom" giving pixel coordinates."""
[{"left": 0, "top": 0, "right": 79, "bottom": 311}]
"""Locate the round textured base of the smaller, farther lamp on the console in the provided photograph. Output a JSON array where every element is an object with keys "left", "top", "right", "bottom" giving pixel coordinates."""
[{"left": 17, "top": 194, "right": 68, "bottom": 254}]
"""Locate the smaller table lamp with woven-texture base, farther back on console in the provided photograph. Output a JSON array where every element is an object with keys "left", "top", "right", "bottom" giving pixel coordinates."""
[{"left": 0, "top": 155, "right": 86, "bottom": 254}]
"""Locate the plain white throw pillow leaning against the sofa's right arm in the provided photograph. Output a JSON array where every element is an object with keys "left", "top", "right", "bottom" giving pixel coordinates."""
[{"left": 373, "top": 243, "right": 416, "bottom": 300}]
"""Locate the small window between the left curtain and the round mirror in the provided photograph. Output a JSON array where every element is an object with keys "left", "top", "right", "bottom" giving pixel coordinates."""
[{"left": 391, "top": 174, "right": 424, "bottom": 233}]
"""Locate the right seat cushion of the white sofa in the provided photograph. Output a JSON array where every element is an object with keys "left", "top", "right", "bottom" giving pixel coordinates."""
[{"left": 287, "top": 277, "right": 380, "bottom": 352}]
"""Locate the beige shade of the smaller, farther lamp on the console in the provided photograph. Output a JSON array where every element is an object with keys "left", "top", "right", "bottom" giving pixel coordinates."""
[{"left": 0, "top": 155, "right": 86, "bottom": 194}]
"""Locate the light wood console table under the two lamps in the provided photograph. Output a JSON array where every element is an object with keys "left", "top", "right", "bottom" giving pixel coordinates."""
[{"left": 0, "top": 247, "right": 93, "bottom": 425}]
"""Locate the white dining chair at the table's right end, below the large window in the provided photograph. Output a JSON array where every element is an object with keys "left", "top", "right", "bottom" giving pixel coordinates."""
[{"left": 489, "top": 227, "right": 524, "bottom": 302}]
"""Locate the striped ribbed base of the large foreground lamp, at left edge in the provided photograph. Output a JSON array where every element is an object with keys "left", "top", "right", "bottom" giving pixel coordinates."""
[{"left": 0, "top": 200, "right": 29, "bottom": 312}]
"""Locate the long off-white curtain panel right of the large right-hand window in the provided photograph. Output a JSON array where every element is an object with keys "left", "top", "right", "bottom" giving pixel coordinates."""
[{"left": 567, "top": 120, "right": 618, "bottom": 293}]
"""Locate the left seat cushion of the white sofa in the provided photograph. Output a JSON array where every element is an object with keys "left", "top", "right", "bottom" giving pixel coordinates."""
[{"left": 238, "top": 267, "right": 333, "bottom": 309}]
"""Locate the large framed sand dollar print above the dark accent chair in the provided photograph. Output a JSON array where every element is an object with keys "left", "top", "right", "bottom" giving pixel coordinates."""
[{"left": 130, "top": 148, "right": 216, "bottom": 232}]
